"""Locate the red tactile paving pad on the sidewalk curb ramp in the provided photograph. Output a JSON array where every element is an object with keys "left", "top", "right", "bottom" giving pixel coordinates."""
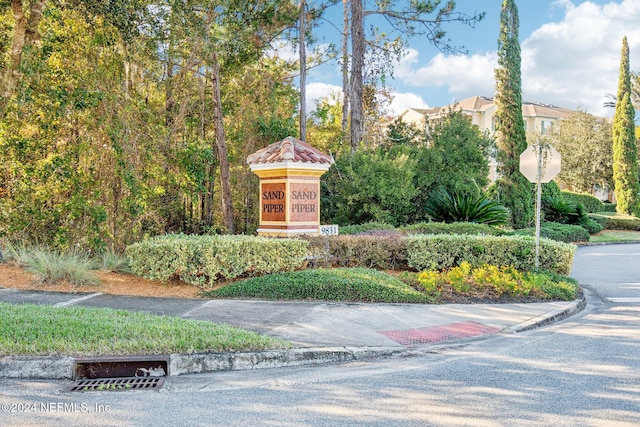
[{"left": 380, "top": 321, "right": 500, "bottom": 346}]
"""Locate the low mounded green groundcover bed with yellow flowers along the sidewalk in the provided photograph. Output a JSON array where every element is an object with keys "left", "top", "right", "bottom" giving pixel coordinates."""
[{"left": 205, "top": 268, "right": 578, "bottom": 303}]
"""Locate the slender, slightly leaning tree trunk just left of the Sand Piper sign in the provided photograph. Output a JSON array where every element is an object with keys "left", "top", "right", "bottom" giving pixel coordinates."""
[{"left": 211, "top": 53, "right": 234, "bottom": 234}]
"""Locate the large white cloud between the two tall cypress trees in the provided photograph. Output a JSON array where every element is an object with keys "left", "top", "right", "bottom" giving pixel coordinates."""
[{"left": 522, "top": 0, "right": 640, "bottom": 115}]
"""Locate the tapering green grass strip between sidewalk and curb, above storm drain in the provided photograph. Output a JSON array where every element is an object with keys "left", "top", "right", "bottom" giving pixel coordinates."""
[{"left": 0, "top": 302, "right": 291, "bottom": 356}]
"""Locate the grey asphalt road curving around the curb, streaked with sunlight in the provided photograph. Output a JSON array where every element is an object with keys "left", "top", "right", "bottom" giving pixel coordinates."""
[{"left": 0, "top": 245, "right": 640, "bottom": 427}]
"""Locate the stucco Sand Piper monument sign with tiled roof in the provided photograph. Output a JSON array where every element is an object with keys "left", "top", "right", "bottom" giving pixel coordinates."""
[{"left": 247, "top": 137, "right": 334, "bottom": 236}]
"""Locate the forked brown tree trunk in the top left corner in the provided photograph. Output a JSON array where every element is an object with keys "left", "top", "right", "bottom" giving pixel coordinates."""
[{"left": 0, "top": 0, "right": 44, "bottom": 116}]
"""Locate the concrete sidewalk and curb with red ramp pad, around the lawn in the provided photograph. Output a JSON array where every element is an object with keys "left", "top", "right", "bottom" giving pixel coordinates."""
[{"left": 0, "top": 288, "right": 585, "bottom": 378}]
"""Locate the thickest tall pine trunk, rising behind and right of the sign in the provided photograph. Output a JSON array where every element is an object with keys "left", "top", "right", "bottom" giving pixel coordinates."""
[{"left": 350, "top": 0, "right": 366, "bottom": 153}]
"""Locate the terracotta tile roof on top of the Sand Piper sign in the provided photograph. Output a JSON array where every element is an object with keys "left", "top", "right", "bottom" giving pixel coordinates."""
[{"left": 247, "top": 136, "right": 333, "bottom": 164}]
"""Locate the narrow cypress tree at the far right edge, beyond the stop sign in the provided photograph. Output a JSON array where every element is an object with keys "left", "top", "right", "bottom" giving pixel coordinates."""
[{"left": 613, "top": 37, "right": 640, "bottom": 215}]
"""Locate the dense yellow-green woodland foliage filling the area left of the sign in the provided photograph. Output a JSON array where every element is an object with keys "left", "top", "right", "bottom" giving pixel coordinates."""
[{"left": 0, "top": 0, "right": 298, "bottom": 250}]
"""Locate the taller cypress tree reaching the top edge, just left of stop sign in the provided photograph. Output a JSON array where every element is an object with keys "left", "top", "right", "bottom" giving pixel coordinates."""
[{"left": 495, "top": 0, "right": 534, "bottom": 228}]
